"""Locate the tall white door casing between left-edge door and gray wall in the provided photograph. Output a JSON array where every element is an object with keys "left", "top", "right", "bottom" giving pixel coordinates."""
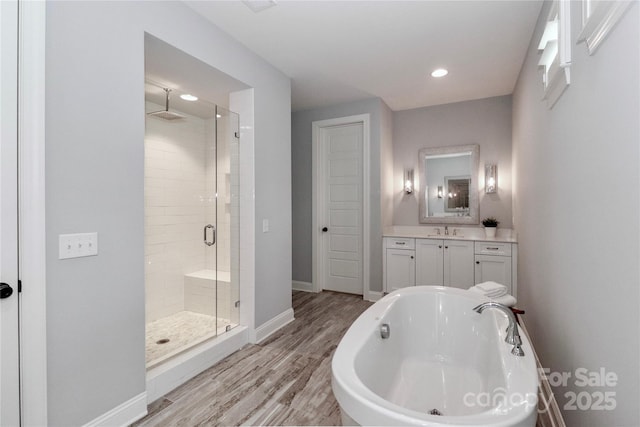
[{"left": 18, "top": 1, "right": 47, "bottom": 425}]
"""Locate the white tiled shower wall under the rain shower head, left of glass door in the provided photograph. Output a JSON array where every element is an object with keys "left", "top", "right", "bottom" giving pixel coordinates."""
[{"left": 144, "top": 103, "right": 221, "bottom": 322}]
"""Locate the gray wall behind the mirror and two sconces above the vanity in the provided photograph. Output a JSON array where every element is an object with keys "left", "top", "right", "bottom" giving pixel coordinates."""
[{"left": 392, "top": 95, "right": 512, "bottom": 228}]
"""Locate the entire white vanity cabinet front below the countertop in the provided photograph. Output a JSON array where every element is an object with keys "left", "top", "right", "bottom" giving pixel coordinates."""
[{"left": 382, "top": 237, "right": 518, "bottom": 296}]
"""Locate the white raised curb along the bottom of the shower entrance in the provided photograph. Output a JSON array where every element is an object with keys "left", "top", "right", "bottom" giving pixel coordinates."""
[{"left": 146, "top": 326, "right": 248, "bottom": 403}]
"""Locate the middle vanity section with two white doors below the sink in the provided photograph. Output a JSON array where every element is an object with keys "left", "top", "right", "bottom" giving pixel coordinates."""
[{"left": 415, "top": 239, "right": 474, "bottom": 289}]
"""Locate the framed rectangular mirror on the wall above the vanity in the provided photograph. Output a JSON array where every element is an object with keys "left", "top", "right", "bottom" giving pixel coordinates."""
[{"left": 418, "top": 145, "right": 480, "bottom": 224}]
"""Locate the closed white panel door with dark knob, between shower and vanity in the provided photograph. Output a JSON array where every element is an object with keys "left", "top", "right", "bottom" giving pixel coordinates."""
[{"left": 321, "top": 123, "right": 364, "bottom": 295}]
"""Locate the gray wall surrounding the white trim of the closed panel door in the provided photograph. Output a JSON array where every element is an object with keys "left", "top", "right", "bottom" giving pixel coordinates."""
[{"left": 291, "top": 98, "right": 390, "bottom": 291}]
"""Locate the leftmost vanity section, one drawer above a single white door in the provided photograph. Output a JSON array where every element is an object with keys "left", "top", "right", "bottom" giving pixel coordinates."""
[{"left": 382, "top": 238, "right": 416, "bottom": 292}]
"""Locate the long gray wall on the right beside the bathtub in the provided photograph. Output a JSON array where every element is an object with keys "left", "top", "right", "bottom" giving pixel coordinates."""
[{"left": 513, "top": 2, "right": 640, "bottom": 426}]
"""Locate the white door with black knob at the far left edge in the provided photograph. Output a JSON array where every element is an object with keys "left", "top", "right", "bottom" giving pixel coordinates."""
[{"left": 0, "top": 1, "right": 20, "bottom": 426}]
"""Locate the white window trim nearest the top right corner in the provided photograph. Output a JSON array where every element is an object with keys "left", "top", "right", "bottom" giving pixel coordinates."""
[{"left": 577, "top": 0, "right": 633, "bottom": 55}]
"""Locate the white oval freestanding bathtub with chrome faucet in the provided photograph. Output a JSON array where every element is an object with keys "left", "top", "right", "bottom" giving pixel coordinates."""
[{"left": 332, "top": 286, "right": 538, "bottom": 426}]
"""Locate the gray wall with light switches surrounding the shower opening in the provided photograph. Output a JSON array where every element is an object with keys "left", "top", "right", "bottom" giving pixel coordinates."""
[{"left": 46, "top": 2, "right": 291, "bottom": 425}]
